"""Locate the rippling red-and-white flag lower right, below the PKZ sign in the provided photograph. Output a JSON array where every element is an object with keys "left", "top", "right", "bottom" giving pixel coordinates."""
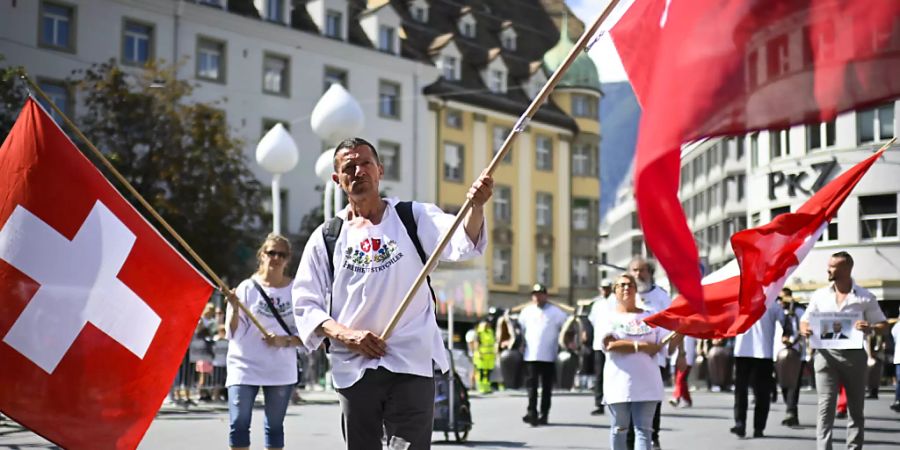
[{"left": 646, "top": 149, "right": 884, "bottom": 339}]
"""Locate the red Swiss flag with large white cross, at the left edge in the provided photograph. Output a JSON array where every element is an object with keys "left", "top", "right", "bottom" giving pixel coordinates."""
[{"left": 0, "top": 99, "right": 212, "bottom": 449}]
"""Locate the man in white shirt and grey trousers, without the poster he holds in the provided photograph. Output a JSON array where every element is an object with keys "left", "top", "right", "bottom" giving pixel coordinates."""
[{"left": 800, "top": 252, "right": 887, "bottom": 450}]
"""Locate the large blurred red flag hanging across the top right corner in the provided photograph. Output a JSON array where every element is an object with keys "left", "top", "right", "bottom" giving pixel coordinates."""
[{"left": 612, "top": 0, "right": 900, "bottom": 310}]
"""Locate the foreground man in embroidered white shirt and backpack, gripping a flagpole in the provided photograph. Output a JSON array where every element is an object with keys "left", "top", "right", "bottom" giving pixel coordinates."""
[{"left": 293, "top": 138, "right": 493, "bottom": 450}]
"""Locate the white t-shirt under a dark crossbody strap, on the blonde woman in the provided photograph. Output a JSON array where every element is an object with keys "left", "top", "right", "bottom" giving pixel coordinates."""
[{"left": 225, "top": 279, "right": 297, "bottom": 386}]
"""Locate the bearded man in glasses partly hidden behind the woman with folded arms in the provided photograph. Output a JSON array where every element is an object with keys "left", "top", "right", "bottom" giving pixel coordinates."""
[{"left": 628, "top": 256, "right": 683, "bottom": 450}]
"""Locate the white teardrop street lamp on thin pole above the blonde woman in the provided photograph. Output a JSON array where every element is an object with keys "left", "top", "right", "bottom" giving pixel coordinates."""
[{"left": 256, "top": 123, "right": 299, "bottom": 234}]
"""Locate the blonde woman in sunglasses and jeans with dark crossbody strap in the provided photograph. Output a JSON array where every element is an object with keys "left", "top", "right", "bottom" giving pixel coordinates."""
[{"left": 225, "top": 234, "right": 301, "bottom": 450}]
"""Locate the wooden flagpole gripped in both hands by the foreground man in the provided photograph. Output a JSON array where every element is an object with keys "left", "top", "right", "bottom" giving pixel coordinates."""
[{"left": 381, "top": 0, "right": 619, "bottom": 339}]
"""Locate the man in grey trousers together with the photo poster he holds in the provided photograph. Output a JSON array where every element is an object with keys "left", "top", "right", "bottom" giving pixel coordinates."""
[{"left": 800, "top": 252, "right": 887, "bottom": 450}]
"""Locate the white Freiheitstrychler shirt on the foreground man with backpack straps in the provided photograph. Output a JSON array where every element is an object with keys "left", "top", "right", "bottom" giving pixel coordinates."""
[{"left": 293, "top": 198, "right": 487, "bottom": 389}]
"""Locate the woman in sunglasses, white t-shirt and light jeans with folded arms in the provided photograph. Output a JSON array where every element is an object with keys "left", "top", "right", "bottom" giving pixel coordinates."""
[{"left": 596, "top": 274, "right": 663, "bottom": 450}]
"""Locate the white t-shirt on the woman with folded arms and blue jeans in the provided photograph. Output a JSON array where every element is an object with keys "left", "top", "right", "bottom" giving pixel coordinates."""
[{"left": 594, "top": 311, "right": 665, "bottom": 404}]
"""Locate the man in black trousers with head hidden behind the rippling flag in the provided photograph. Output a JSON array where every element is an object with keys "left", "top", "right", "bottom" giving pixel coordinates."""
[{"left": 730, "top": 301, "right": 785, "bottom": 437}]
